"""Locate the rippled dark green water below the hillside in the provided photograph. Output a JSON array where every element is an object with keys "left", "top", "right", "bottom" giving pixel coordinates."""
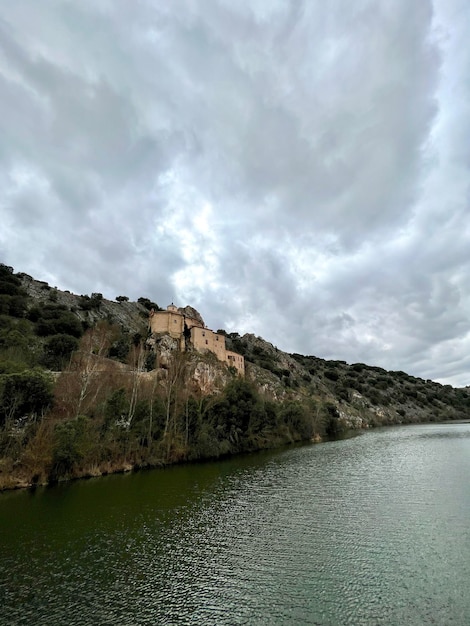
[{"left": 0, "top": 423, "right": 470, "bottom": 626}]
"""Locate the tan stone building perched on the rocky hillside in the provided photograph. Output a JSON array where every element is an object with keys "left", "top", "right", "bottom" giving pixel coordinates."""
[{"left": 149, "top": 303, "right": 245, "bottom": 376}]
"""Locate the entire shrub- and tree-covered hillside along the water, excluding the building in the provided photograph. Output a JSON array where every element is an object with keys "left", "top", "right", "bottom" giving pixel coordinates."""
[{"left": 0, "top": 265, "right": 470, "bottom": 488}]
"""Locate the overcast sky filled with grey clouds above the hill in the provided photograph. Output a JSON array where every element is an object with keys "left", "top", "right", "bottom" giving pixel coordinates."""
[{"left": 0, "top": 0, "right": 470, "bottom": 386}]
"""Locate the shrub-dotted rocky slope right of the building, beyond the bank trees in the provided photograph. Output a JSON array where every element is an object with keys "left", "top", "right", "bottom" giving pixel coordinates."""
[{"left": 232, "top": 335, "right": 470, "bottom": 428}]
